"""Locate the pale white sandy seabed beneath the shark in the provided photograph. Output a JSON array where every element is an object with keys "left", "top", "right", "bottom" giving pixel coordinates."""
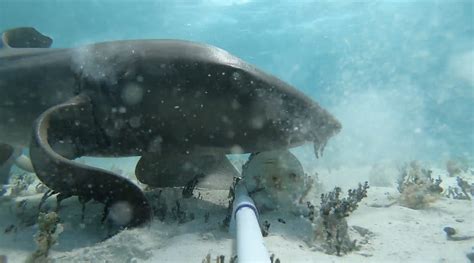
[{"left": 0, "top": 159, "right": 474, "bottom": 263}]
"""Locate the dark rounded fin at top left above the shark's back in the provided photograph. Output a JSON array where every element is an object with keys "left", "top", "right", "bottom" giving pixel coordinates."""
[{"left": 0, "top": 27, "right": 53, "bottom": 48}]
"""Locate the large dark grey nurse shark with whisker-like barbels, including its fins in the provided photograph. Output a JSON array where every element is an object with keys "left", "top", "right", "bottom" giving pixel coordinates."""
[{"left": 0, "top": 27, "right": 341, "bottom": 227}]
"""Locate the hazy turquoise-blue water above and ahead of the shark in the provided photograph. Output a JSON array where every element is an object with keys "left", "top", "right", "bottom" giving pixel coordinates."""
[{"left": 0, "top": 0, "right": 474, "bottom": 163}]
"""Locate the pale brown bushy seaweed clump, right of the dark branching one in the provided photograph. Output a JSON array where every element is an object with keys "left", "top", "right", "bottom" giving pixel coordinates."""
[{"left": 397, "top": 161, "right": 443, "bottom": 209}]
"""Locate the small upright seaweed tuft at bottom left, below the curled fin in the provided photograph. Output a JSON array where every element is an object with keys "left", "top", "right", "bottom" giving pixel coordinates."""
[{"left": 26, "top": 212, "right": 63, "bottom": 263}]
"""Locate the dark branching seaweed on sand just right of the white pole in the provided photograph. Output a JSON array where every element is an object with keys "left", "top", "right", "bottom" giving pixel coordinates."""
[{"left": 308, "top": 182, "right": 369, "bottom": 256}]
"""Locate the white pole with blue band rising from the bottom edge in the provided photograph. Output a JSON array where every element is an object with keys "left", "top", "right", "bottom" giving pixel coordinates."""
[{"left": 230, "top": 184, "right": 270, "bottom": 263}]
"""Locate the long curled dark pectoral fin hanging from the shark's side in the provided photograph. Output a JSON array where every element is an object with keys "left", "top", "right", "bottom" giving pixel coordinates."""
[{"left": 30, "top": 95, "right": 152, "bottom": 227}]
